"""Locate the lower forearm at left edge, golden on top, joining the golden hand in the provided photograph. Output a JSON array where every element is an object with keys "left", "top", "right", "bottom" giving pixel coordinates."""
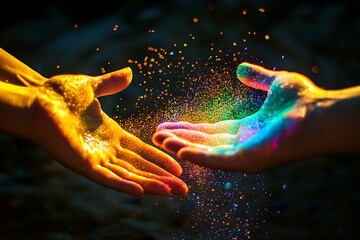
[{"left": 0, "top": 82, "right": 37, "bottom": 138}]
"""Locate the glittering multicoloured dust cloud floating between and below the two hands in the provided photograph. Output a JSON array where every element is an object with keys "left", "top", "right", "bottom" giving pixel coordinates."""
[{"left": 118, "top": 43, "right": 271, "bottom": 239}]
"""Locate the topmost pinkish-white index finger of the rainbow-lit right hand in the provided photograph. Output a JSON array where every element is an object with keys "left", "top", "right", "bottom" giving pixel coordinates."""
[{"left": 156, "top": 120, "right": 240, "bottom": 134}]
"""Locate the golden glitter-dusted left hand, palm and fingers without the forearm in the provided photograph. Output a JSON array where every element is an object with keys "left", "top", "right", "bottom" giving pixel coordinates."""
[{"left": 29, "top": 68, "right": 187, "bottom": 196}]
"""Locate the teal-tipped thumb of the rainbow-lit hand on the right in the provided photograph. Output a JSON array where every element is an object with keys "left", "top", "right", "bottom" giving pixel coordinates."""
[{"left": 236, "top": 62, "right": 285, "bottom": 91}]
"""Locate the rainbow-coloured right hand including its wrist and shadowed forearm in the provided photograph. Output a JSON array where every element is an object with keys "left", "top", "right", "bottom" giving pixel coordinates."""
[{"left": 152, "top": 62, "right": 360, "bottom": 174}]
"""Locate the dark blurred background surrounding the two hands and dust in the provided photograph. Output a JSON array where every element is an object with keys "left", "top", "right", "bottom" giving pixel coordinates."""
[{"left": 0, "top": 0, "right": 360, "bottom": 239}]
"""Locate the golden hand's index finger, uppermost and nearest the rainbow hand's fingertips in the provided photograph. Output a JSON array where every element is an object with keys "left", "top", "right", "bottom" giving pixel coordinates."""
[{"left": 121, "top": 132, "right": 182, "bottom": 176}]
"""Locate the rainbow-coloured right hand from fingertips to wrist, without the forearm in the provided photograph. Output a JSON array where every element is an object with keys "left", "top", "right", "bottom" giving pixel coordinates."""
[{"left": 152, "top": 63, "right": 332, "bottom": 173}]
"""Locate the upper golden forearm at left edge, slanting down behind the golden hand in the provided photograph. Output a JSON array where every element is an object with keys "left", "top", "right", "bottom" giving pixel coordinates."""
[{"left": 0, "top": 48, "right": 46, "bottom": 86}]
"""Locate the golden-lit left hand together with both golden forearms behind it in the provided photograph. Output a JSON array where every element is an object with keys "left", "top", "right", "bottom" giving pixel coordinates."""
[{"left": 0, "top": 49, "right": 188, "bottom": 196}]
